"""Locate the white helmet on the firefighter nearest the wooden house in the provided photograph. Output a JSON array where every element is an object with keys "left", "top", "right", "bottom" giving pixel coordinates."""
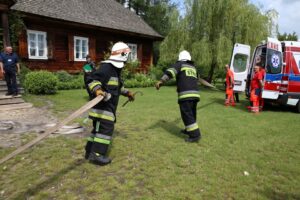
[{"left": 106, "top": 42, "right": 130, "bottom": 68}]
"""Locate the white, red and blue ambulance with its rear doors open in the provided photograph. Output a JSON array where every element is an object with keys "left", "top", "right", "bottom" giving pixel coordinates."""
[{"left": 230, "top": 38, "right": 300, "bottom": 113}]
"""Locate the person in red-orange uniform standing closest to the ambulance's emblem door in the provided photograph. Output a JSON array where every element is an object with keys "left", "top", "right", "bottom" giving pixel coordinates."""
[{"left": 250, "top": 65, "right": 263, "bottom": 113}]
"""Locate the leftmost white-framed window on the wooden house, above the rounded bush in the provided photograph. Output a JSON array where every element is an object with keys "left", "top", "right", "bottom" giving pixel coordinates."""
[{"left": 27, "top": 30, "right": 48, "bottom": 59}]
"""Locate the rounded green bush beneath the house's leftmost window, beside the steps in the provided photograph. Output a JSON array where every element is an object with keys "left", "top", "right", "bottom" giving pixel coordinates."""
[{"left": 24, "top": 71, "right": 58, "bottom": 94}]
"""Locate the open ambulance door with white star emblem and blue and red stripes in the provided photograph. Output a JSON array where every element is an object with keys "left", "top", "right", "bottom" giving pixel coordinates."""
[{"left": 262, "top": 38, "right": 283, "bottom": 99}]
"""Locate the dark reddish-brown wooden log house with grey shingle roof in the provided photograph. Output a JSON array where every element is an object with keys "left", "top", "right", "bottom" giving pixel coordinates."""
[{"left": 0, "top": 0, "right": 163, "bottom": 77}]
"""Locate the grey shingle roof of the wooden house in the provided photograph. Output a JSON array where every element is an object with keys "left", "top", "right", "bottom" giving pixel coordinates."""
[{"left": 11, "top": 0, "right": 162, "bottom": 39}]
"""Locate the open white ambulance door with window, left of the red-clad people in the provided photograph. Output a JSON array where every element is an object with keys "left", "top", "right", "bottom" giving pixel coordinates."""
[{"left": 230, "top": 43, "right": 251, "bottom": 92}]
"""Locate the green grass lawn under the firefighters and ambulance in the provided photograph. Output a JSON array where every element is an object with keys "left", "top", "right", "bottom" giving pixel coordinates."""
[{"left": 0, "top": 87, "right": 300, "bottom": 199}]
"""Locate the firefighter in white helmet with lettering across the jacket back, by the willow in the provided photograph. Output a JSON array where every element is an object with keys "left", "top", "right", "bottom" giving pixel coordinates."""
[{"left": 155, "top": 51, "right": 201, "bottom": 142}]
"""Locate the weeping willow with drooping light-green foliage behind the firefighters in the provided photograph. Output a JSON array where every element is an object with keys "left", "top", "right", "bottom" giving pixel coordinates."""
[{"left": 160, "top": 0, "right": 268, "bottom": 82}]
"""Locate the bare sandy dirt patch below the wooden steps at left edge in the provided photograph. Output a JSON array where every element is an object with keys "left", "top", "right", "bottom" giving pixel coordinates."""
[{"left": 0, "top": 107, "right": 58, "bottom": 148}]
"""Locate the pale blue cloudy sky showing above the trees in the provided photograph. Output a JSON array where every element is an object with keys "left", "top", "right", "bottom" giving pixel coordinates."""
[{"left": 171, "top": 0, "right": 300, "bottom": 38}]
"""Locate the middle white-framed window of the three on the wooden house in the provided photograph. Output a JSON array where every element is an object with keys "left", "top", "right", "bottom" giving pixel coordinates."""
[{"left": 74, "top": 36, "right": 89, "bottom": 61}]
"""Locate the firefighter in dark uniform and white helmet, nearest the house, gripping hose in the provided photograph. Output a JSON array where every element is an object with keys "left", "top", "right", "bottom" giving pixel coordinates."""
[{"left": 85, "top": 42, "right": 134, "bottom": 165}]
